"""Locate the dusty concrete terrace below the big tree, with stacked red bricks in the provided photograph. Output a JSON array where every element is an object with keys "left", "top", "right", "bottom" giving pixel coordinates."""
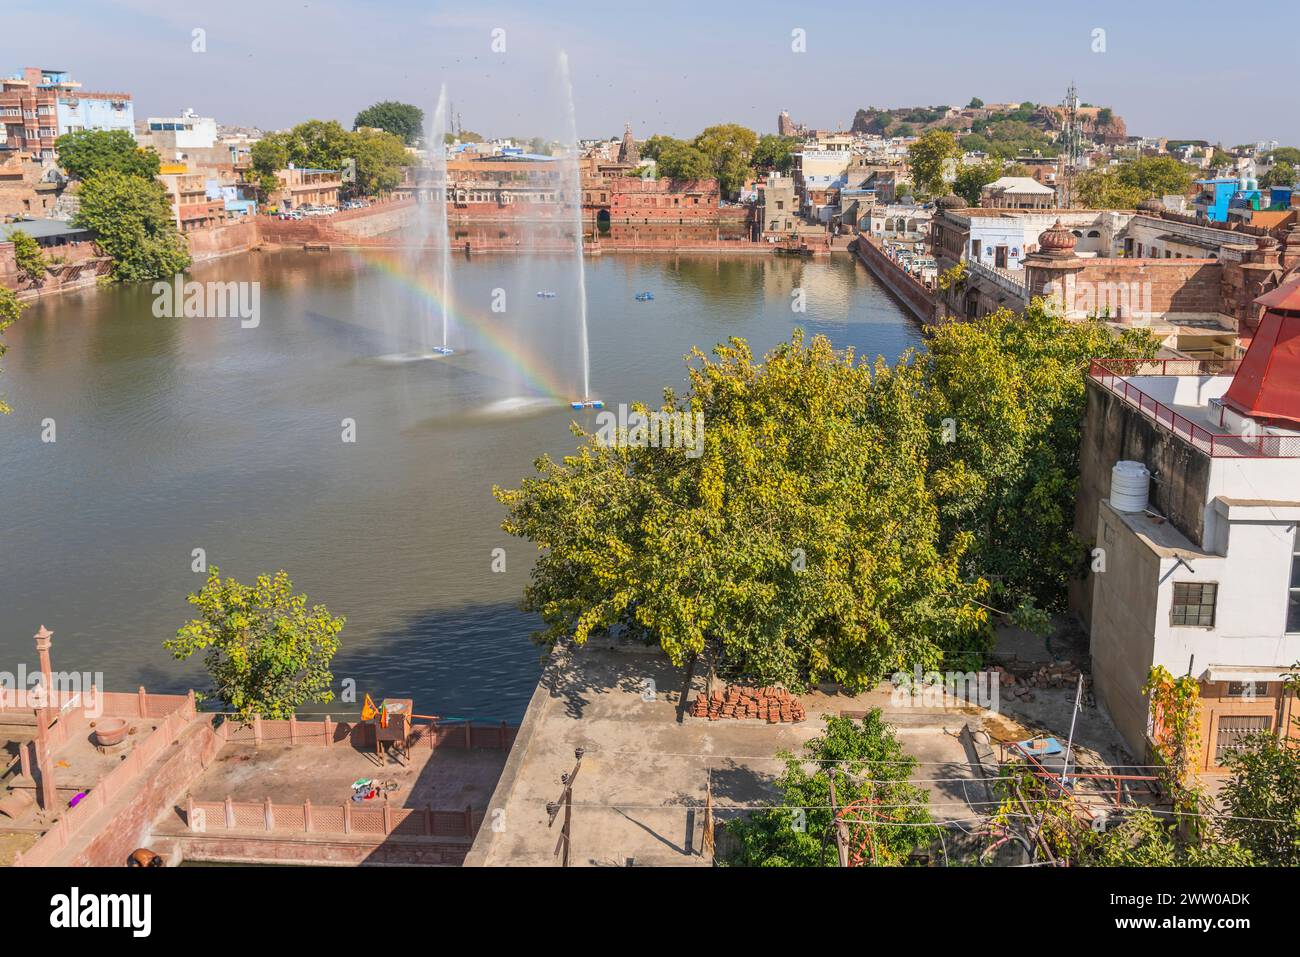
[{"left": 467, "top": 645, "right": 983, "bottom": 866}]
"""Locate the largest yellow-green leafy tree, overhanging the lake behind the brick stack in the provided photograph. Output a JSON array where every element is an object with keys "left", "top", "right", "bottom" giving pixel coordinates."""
[{"left": 495, "top": 333, "right": 985, "bottom": 689}]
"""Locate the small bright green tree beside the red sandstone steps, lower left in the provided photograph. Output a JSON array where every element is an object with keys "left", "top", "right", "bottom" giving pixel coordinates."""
[{"left": 163, "top": 566, "right": 346, "bottom": 722}]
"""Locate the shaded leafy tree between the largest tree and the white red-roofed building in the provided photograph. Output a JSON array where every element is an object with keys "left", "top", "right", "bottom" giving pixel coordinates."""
[{"left": 914, "top": 300, "right": 1157, "bottom": 611}]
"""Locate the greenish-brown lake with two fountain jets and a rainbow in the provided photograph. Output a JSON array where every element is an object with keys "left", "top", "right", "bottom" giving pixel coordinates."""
[{"left": 0, "top": 251, "right": 920, "bottom": 720}]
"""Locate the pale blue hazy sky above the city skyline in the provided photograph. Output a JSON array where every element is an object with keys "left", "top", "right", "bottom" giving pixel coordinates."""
[{"left": 0, "top": 0, "right": 1300, "bottom": 146}]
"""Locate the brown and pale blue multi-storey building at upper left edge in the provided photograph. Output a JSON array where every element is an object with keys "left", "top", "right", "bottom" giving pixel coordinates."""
[{"left": 0, "top": 66, "right": 135, "bottom": 160}]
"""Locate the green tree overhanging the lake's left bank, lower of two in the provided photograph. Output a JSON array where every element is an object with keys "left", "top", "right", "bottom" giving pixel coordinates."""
[{"left": 73, "top": 172, "right": 190, "bottom": 282}]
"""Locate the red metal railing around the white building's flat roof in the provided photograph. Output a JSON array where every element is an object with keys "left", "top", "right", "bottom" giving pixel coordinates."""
[{"left": 1088, "top": 359, "right": 1300, "bottom": 459}]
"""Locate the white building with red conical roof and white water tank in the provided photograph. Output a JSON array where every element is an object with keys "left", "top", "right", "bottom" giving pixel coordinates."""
[{"left": 1071, "top": 281, "right": 1300, "bottom": 771}]
